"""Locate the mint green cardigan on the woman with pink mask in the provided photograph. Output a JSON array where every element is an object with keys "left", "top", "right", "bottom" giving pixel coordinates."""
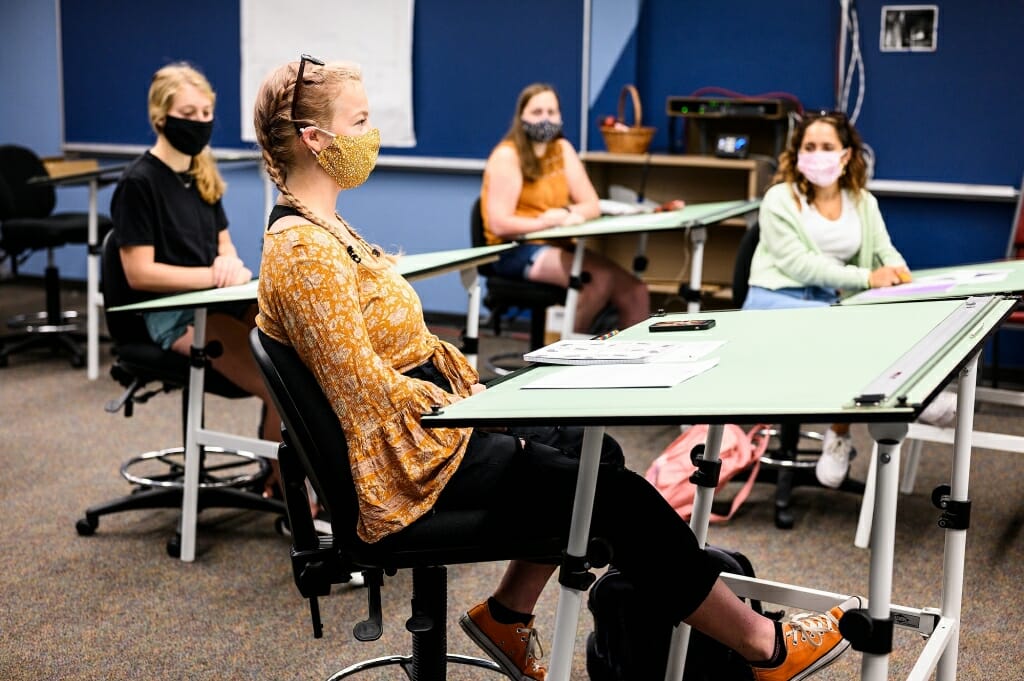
[{"left": 750, "top": 183, "right": 906, "bottom": 291}]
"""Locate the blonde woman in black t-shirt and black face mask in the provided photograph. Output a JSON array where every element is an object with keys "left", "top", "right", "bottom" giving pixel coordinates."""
[{"left": 111, "top": 62, "right": 281, "bottom": 494}]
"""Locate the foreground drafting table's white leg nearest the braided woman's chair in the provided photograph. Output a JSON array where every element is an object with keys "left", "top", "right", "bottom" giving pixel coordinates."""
[{"left": 548, "top": 426, "right": 604, "bottom": 681}]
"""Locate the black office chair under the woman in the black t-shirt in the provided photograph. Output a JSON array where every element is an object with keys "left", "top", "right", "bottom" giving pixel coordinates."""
[{"left": 75, "top": 232, "right": 285, "bottom": 558}]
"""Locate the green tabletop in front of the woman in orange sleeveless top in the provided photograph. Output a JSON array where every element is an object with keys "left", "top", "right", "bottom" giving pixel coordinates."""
[{"left": 522, "top": 199, "right": 761, "bottom": 241}]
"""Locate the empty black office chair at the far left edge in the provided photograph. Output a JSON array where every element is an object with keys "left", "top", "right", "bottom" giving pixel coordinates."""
[{"left": 0, "top": 144, "right": 113, "bottom": 368}]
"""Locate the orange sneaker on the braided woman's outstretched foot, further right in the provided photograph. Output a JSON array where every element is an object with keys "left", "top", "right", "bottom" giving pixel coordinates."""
[{"left": 751, "top": 596, "right": 861, "bottom": 681}]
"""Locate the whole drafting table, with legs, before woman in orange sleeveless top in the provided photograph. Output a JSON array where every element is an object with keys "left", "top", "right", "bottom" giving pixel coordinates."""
[{"left": 520, "top": 199, "right": 761, "bottom": 338}]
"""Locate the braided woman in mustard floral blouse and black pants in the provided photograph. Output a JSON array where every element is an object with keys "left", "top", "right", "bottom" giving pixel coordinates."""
[{"left": 255, "top": 55, "right": 859, "bottom": 681}]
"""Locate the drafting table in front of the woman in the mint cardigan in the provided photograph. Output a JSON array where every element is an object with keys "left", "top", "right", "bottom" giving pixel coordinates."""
[{"left": 840, "top": 260, "right": 1024, "bottom": 549}]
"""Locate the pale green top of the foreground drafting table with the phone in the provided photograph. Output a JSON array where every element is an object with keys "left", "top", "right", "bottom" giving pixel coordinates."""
[{"left": 423, "top": 296, "right": 1016, "bottom": 427}]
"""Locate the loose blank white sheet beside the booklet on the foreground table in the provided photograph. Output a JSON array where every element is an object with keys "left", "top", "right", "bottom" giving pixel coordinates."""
[{"left": 522, "top": 357, "right": 718, "bottom": 390}]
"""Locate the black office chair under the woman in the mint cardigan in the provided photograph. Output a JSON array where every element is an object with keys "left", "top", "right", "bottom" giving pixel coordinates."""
[{"left": 732, "top": 223, "right": 864, "bottom": 529}]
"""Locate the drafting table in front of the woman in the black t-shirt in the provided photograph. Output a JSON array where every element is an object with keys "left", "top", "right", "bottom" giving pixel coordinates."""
[{"left": 111, "top": 244, "right": 515, "bottom": 562}]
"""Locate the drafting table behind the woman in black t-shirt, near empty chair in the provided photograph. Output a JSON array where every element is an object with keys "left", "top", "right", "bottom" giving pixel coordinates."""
[{"left": 29, "top": 164, "right": 128, "bottom": 380}]
